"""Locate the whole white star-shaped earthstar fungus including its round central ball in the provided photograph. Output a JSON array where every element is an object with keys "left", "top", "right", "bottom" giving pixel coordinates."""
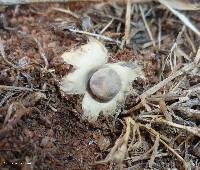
[{"left": 60, "top": 38, "right": 144, "bottom": 122}]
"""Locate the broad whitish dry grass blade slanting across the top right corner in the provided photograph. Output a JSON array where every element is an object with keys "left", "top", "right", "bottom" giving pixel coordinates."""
[{"left": 158, "top": 0, "right": 200, "bottom": 36}]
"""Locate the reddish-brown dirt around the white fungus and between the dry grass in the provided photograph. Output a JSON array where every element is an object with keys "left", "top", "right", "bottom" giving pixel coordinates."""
[{"left": 0, "top": 2, "right": 200, "bottom": 170}]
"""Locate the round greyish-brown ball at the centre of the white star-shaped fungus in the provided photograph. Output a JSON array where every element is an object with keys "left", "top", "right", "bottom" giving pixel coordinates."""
[{"left": 89, "top": 68, "right": 121, "bottom": 101}]
